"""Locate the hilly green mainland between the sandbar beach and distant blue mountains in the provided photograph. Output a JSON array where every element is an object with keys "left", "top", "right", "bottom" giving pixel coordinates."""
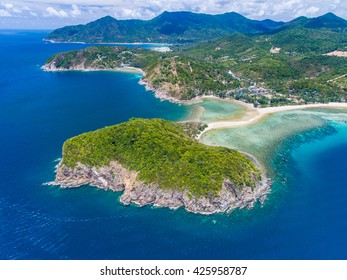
[{"left": 44, "top": 11, "right": 347, "bottom": 107}]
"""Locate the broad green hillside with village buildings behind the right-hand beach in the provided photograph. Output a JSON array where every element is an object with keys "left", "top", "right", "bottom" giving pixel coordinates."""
[{"left": 182, "top": 27, "right": 347, "bottom": 106}]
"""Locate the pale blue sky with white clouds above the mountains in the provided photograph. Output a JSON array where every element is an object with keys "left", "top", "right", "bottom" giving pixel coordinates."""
[{"left": 0, "top": 0, "right": 347, "bottom": 29}]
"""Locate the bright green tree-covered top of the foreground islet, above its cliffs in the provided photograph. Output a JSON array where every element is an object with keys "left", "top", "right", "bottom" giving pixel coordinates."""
[{"left": 62, "top": 119, "right": 261, "bottom": 197}]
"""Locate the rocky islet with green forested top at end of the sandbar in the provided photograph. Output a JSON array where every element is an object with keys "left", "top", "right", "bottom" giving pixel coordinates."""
[{"left": 51, "top": 119, "right": 270, "bottom": 214}]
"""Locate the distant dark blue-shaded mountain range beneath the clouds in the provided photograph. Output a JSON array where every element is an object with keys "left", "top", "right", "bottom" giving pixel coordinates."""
[{"left": 45, "top": 12, "right": 347, "bottom": 43}]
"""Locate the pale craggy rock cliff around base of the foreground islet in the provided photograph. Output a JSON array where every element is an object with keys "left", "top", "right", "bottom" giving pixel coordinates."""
[{"left": 51, "top": 161, "right": 269, "bottom": 215}]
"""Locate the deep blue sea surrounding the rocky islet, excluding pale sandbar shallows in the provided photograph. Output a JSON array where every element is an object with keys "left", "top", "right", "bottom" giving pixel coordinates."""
[{"left": 0, "top": 31, "right": 347, "bottom": 259}]
